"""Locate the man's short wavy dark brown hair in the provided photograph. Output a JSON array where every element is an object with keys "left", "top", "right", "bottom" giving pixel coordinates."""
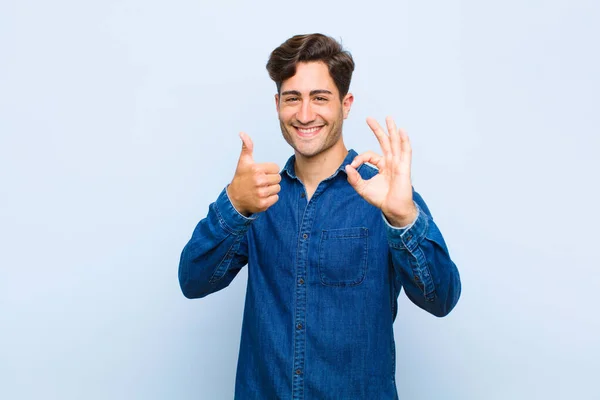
[{"left": 267, "top": 33, "right": 354, "bottom": 100}]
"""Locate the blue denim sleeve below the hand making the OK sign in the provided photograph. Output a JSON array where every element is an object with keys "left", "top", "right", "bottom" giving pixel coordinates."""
[{"left": 384, "top": 191, "right": 461, "bottom": 317}]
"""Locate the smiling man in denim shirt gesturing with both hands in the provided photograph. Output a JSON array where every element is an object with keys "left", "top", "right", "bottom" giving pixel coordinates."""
[{"left": 179, "top": 34, "right": 460, "bottom": 399}]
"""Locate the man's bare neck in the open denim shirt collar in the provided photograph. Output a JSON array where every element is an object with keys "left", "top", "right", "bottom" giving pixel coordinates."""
[{"left": 294, "top": 140, "right": 348, "bottom": 198}]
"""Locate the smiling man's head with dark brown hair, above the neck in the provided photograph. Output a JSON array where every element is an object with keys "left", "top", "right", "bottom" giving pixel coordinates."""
[{"left": 267, "top": 34, "right": 354, "bottom": 157}]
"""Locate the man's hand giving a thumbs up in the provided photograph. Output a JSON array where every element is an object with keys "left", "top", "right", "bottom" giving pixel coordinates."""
[{"left": 227, "top": 132, "right": 281, "bottom": 216}]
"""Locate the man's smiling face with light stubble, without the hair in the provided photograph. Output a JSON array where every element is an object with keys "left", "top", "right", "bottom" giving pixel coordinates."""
[{"left": 275, "top": 61, "right": 354, "bottom": 158}]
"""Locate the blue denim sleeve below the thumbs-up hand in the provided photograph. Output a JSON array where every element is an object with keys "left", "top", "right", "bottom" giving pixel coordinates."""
[{"left": 179, "top": 188, "right": 257, "bottom": 299}]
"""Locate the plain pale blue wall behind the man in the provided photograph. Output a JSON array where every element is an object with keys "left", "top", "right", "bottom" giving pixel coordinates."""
[{"left": 0, "top": 0, "right": 600, "bottom": 400}]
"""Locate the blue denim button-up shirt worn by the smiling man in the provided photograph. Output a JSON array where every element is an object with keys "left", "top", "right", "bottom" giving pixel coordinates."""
[{"left": 179, "top": 150, "right": 461, "bottom": 399}]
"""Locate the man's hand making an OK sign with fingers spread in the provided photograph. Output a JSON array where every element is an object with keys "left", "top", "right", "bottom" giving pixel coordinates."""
[{"left": 346, "top": 117, "right": 418, "bottom": 227}]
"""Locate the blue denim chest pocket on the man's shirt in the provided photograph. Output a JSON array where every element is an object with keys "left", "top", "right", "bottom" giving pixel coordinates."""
[{"left": 319, "top": 227, "right": 369, "bottom": 286}]
